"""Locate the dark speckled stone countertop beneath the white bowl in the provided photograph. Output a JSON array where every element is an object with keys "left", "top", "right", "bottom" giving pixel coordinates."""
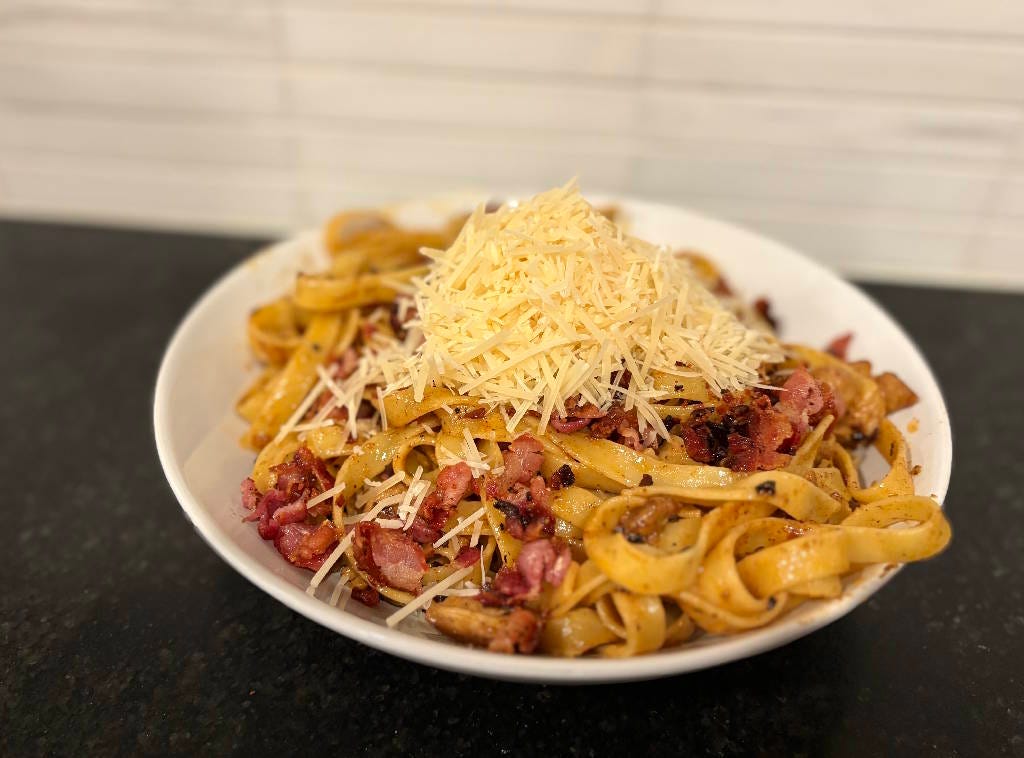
[{"left": 0, "top": 216, "right": 1024, "bottom": 756}]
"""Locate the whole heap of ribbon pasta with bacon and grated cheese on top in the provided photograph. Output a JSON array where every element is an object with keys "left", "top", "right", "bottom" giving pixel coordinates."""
[{"left": 238, "top": 183, "right": 950, "bottom": 657}]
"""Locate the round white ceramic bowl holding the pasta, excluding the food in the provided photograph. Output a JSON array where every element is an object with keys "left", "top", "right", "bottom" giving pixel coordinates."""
[{"left": 154, "top": 192, "right": 952, "bottom": 683}]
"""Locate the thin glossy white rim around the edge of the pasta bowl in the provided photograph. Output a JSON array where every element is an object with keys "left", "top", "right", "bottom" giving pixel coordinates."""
[{"left": 153, "top": 195, "right": 952, "bottom": 684}]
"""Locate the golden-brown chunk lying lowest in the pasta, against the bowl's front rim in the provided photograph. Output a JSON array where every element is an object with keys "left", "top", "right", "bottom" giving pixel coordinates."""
[{"left": 427, "top": 597, "right": 541, "bottom": 654}]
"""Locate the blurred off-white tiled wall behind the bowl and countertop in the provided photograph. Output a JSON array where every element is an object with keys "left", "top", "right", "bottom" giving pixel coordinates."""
[{"left": 0, "top": 0, "right": 1024, "bottom": 289}]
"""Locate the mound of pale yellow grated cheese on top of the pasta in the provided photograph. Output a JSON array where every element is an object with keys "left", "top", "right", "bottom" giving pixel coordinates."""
[{"left": 384, "top": 181, "right": 781, "bottom": 436}]
